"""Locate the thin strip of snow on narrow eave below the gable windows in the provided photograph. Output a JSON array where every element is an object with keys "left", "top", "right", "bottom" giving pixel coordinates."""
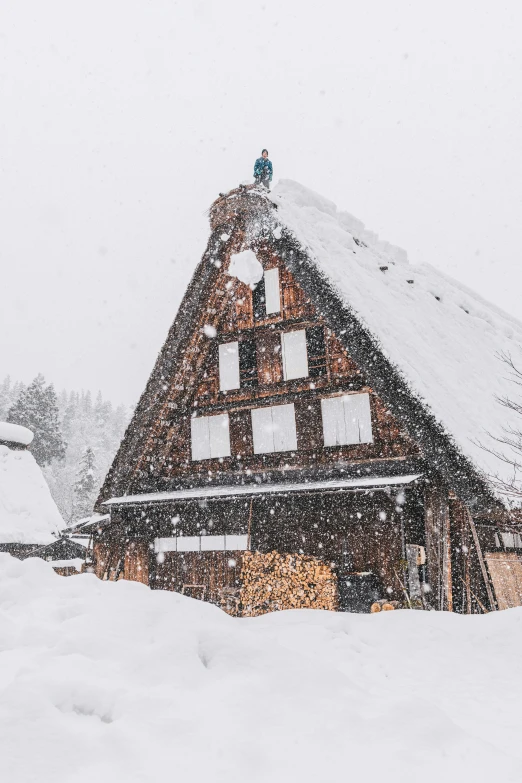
[{"left": 103, "top": 473, "right": 421, "bottom": 506}]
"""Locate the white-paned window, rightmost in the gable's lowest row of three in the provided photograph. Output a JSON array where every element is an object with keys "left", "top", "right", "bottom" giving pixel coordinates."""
[{"left": 321, "top": 394, "right": 373, "bottom": 446}]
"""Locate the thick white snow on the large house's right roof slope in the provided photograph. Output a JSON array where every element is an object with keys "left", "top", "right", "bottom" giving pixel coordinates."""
[{"left": 272, "top": 180, "right": 522, "bottom": 478}]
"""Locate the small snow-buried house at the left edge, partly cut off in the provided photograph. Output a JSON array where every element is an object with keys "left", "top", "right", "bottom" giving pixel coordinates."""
[{"left": 0, "top": 422, "right": 64, "bottom": 558}]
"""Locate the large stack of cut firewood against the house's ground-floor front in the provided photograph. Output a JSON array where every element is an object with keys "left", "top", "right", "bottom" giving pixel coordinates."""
[{"left": 240, "top": 552, "right": 337, "bottom": 617}]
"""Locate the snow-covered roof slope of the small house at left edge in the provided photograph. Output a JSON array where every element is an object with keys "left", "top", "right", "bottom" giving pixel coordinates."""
[{"left": 0, "top": 445, "right": 64, "bottom": 544}]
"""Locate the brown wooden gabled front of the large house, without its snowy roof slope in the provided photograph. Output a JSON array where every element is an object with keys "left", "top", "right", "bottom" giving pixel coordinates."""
[{"left": 94, "top": 188, "right": 516, "bottom": 613}]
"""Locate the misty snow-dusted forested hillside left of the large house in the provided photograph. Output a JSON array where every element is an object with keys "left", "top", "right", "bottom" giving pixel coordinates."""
[{"left": 0, "top": 375, "right": 131, "bottom": 524}]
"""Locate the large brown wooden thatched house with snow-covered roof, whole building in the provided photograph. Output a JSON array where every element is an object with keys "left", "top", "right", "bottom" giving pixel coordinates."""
[{"left": 94, "top": 181, "right": 522, "bottom": 613}]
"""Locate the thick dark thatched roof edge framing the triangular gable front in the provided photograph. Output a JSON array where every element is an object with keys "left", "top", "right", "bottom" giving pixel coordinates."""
[{"left": 96, "top": 183, "right": 500, "bottom": 507}]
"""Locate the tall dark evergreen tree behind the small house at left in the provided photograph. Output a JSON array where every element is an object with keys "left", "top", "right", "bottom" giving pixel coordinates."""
[{"left": 7, "top": 375, "right": 66, "bottom": 465}]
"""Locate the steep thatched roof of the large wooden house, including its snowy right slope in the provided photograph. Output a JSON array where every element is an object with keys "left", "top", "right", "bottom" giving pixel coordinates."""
[{"left": 100, "top": 181, "right": 522, "bottom": 512}]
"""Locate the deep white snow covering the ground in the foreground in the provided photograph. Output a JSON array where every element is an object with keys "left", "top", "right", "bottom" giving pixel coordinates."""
[{"left": 0, "top": 555, "right": 522, "bottom": 783}]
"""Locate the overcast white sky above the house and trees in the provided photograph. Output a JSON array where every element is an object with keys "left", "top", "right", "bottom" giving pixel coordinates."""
[{"left": 0, "top": 0, "right": 522, "bottom": 403}]
